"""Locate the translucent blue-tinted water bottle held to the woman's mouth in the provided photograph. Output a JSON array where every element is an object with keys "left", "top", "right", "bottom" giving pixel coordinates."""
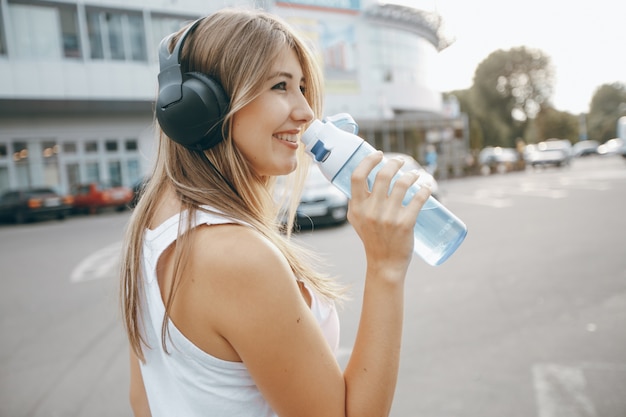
[{"left": 302, "top": 113, "right": 467, "bottom": 266}]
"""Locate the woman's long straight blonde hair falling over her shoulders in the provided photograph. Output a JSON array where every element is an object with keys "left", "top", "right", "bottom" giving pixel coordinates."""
[{"left": 120, "top": 9, "right": 342, "bottom": 360}]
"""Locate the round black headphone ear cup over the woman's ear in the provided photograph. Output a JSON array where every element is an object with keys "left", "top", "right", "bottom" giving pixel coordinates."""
[{"left": 156, "top": 72, "right": 229, "bottom": 149}]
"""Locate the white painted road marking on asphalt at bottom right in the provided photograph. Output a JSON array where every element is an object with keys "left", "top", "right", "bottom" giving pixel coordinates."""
[{"left": 532, "top": 364, "right": 597, "bottom": 417}]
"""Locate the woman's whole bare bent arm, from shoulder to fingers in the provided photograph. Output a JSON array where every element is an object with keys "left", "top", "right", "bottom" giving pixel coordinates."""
[{"left": 172, "top": 155, "right": 428, "bottom": 417}]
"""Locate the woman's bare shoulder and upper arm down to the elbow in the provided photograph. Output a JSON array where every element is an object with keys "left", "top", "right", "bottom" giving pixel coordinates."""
[{"left": 174, "top": 221, "right": 345, "bottom": 415}]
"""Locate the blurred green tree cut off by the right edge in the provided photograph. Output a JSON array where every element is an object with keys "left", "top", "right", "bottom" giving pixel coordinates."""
[{"left": 587, "top": 83, "right": 626, "bottom": 142}]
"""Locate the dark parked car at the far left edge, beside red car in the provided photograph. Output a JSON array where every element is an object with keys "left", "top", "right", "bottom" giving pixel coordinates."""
[{"left": 0, "top": 187, "right": 72, "bottom": 223}]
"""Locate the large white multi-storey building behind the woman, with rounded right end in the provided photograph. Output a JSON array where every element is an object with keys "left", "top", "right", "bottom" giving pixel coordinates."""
[{"left": 0, "top": 0, "right": 467, "bottom": 192}]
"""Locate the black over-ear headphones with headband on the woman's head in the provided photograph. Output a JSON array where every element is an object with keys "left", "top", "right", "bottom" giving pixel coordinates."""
[{"left": 156, "top": 19, "right": 230, "bottom": 150}]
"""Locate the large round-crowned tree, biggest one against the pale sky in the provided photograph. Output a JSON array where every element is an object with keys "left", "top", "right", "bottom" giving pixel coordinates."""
[{"left": 469, "top": 46, "right": 554, "bottom": 146}]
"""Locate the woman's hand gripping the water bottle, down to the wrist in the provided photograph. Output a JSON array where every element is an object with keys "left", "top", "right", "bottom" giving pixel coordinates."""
[{"left": 348, "top": 151, "right": 430, "bottom": 276}]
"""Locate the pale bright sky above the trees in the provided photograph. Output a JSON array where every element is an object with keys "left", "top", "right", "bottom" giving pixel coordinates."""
[{"left": 381, "top": 0, "right": 626, "bottom": 114}]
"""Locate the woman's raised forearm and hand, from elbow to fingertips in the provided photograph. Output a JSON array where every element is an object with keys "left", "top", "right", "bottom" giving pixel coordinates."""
[{"left": 345, "top": 154, "right": 430, "bottom": 416}]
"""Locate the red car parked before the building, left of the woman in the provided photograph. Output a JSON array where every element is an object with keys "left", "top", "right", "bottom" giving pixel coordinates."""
[{"left": 72, "top": 182, "right": 133, "bottom": 214}]
